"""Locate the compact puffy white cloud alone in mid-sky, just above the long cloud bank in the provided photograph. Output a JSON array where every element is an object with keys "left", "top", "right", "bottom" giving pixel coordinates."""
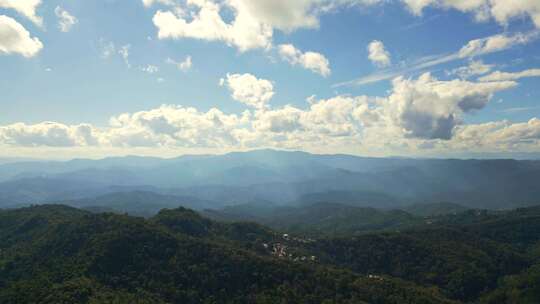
[{"left": 220, "top": 73, "right": 274, "bottom": 109}]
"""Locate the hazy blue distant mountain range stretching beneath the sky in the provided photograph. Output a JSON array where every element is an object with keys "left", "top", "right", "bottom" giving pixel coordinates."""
[{"left": 0, "top": 150, "right": 540, "bottom": 209}]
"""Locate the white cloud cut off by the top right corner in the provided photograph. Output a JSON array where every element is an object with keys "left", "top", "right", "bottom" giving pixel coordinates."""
[{"left": 402, "top": 0, "right": 540, "bottom": 28}]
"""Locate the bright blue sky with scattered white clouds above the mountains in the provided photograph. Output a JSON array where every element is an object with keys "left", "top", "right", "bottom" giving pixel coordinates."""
[{"left": 0, "top": 0, "right": 540, "bottom": 159}]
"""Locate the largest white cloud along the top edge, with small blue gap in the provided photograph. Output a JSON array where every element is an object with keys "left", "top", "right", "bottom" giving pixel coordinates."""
[{"left": 150, "top": 0, "right": 382, "bottom": 52}]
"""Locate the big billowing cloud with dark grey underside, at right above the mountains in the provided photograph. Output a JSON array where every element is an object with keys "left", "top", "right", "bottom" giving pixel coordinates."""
[{"left": 385, "top": 73, "right": 517, "bottom": 140}]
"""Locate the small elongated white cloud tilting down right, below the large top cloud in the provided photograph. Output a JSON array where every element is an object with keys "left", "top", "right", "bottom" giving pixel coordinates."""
[{"left": 278, "top": 44, "right": 331, "bottom": 77}]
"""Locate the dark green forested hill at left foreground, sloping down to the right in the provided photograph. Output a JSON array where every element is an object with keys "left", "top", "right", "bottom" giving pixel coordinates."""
[{"left": 0, "top": 206, "right": 453, "bottom": 304}]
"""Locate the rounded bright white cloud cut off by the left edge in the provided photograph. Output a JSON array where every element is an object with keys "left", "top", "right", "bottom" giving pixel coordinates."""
[{"left": 0, "top": 15, "right": 43, "bottom": 58}]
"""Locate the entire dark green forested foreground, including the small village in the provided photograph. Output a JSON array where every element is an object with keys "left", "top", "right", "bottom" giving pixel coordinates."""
[{"left": 0, "top": 205, "right": 540, "bottom": 304}]
